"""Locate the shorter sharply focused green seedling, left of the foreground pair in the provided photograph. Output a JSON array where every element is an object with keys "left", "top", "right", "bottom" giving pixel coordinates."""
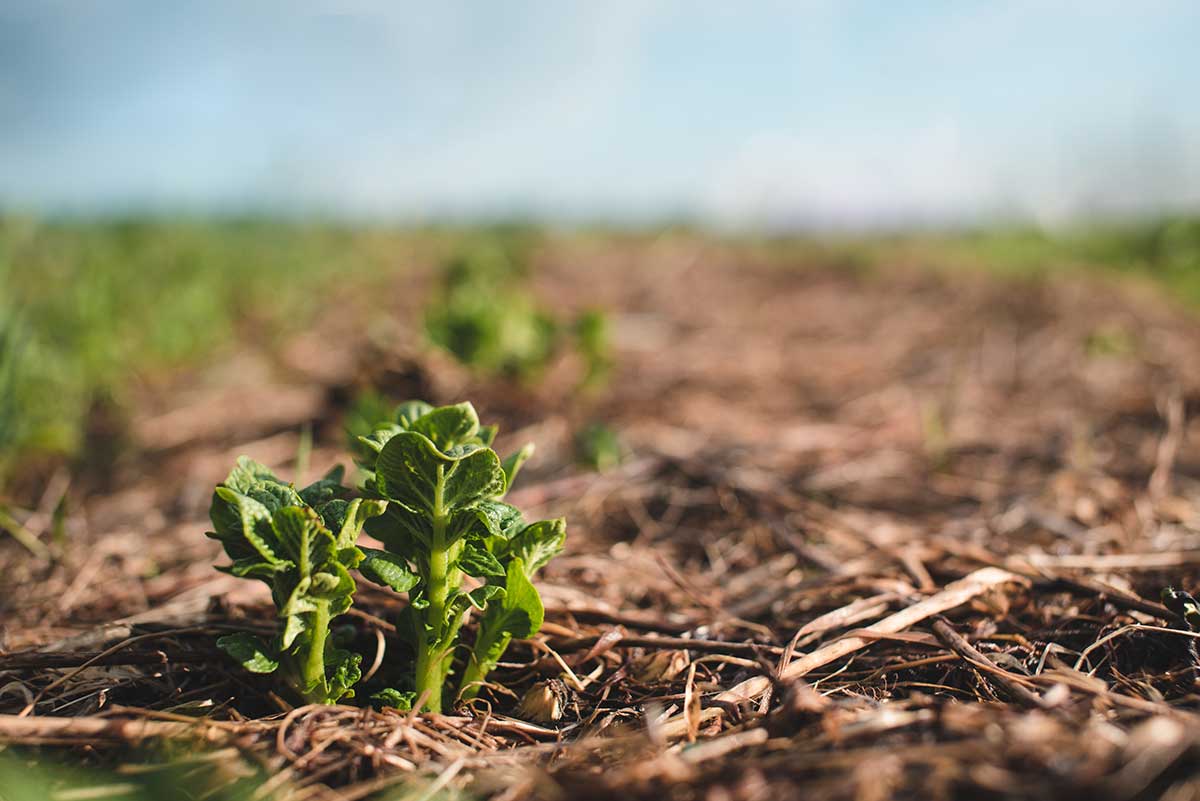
[{"left": 209, "top": 457, "right": 384, "bottom": 704}]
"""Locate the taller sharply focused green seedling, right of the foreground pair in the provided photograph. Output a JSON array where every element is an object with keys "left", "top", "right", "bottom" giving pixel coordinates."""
[{"left": 358, "top": 401, "right": 566, "bottom": 712}]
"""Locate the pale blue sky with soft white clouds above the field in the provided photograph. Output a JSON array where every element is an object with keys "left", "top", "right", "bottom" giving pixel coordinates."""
[{"left": 0, "top": 0, "right": 1200, "bottom": 227}]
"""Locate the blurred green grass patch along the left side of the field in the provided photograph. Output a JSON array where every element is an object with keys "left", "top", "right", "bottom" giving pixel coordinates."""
[{"left": 0, "top": 218, "right": 417, "bottom": 484}]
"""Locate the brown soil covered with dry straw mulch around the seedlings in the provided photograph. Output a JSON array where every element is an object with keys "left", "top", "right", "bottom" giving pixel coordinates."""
[{"left": 0, "top": 239, "right": 1200, "bottom": 801}]
